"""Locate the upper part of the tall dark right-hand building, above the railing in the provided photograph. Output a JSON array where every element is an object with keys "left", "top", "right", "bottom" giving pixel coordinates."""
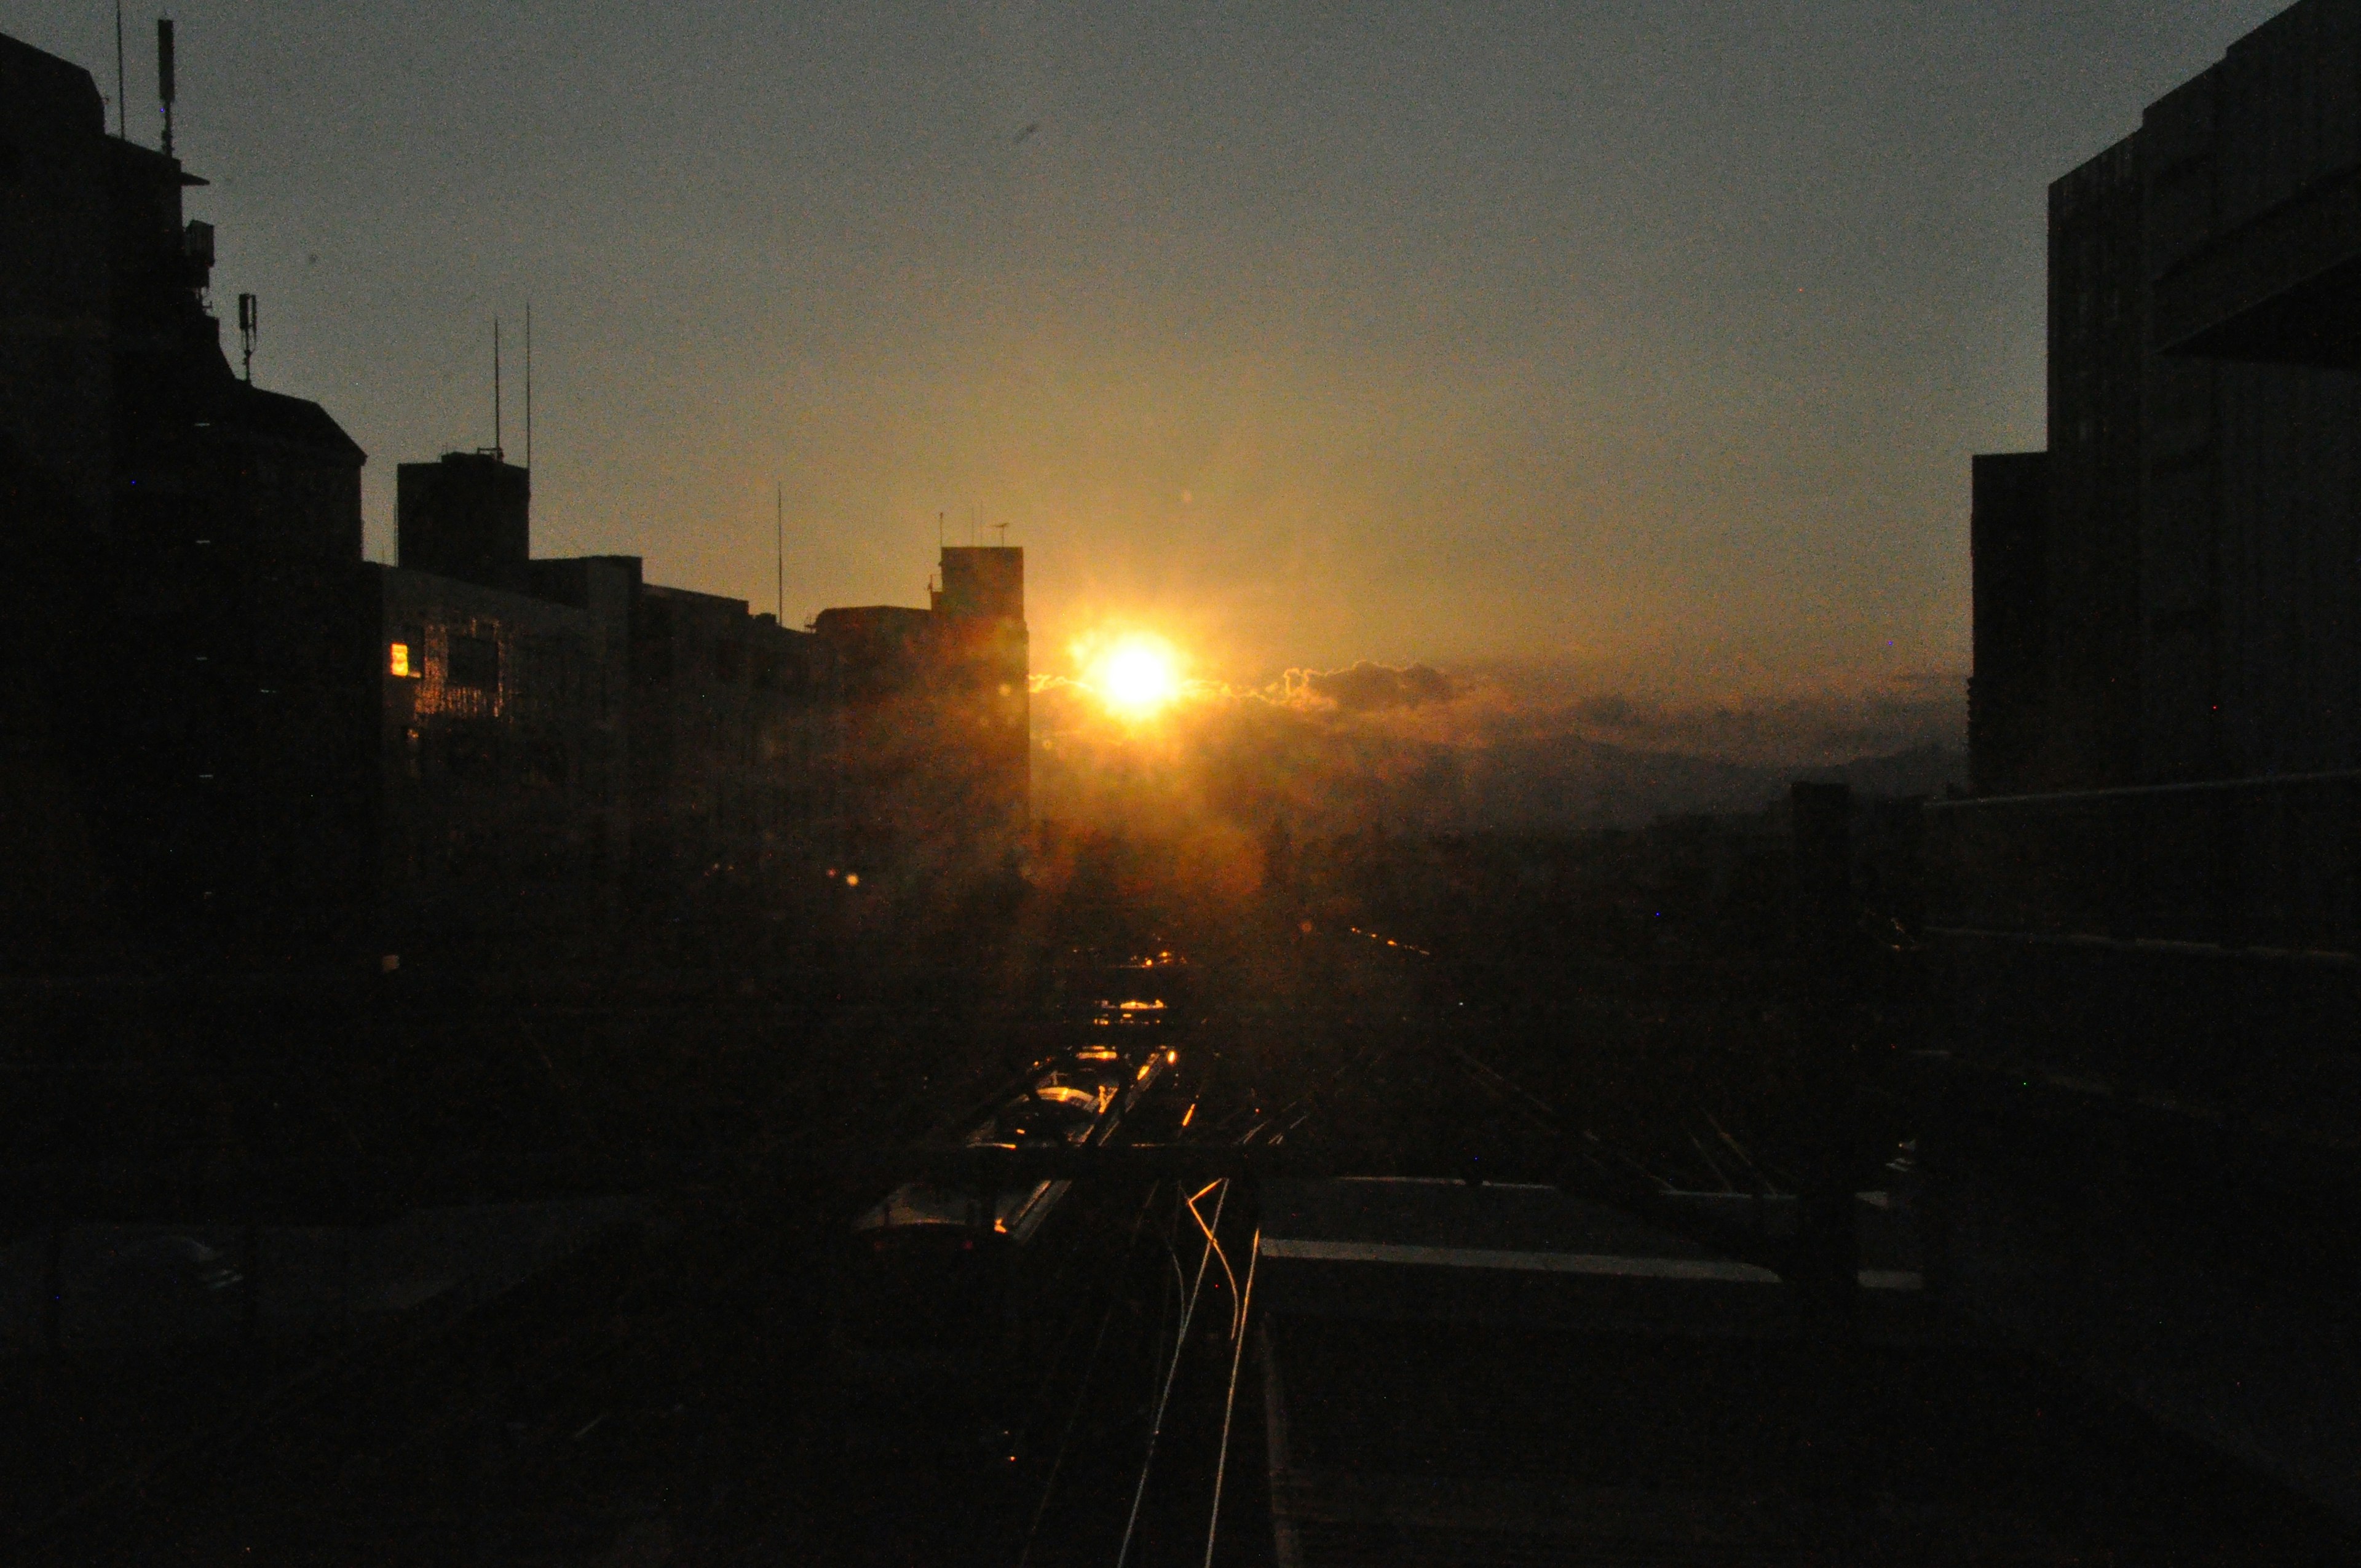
[{"left": 1976, "top": 0, "right": 2361, "bottom": 789}]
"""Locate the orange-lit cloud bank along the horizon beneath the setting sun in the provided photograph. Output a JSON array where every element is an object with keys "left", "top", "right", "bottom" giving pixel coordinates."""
[{"left": 1034, "top": 661, "right": 1964, "bottom": 834}]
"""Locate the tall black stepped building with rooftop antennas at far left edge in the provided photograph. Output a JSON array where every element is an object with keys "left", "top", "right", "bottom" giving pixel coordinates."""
[{"left": 0, "top": 27, "right": 366, "bottom": 954}]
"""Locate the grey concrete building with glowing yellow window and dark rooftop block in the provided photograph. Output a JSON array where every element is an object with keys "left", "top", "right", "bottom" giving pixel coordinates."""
[{"left": 385, "top": 451, "right": 836, "bottom": 930}]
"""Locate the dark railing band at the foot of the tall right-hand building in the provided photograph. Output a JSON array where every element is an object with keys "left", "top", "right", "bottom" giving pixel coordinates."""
[{"left": 1926, "top": 772, "right": 2361, "bottom": 956}]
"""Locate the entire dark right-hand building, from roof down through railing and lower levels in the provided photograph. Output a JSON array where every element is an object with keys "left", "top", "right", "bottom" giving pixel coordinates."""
[{"left": 1926, "top": 0, "right": 2361, "bottom": 1514}]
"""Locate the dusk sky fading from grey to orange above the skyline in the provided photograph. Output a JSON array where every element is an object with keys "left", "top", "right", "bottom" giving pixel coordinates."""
[{"left": 14, "top": 0, "right": 2283, "bottom": 702}]
